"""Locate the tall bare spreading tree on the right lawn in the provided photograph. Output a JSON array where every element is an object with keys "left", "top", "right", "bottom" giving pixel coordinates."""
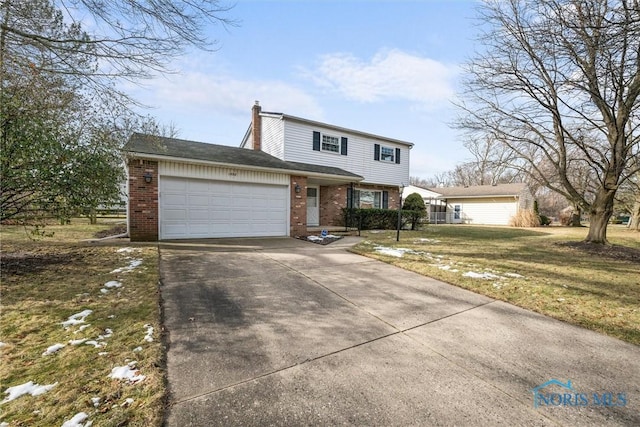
[{"left": 460, "top": 0, "right": 640, "bottom": 244}]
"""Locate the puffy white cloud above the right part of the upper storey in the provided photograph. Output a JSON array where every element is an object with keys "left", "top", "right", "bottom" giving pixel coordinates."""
[{"left": 305, "top": 49, "right": 458, "bottom": 105}]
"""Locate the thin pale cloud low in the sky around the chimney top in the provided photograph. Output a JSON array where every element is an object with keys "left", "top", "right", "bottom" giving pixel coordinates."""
[{"left": 129, "top": 72, "right": 323, "bottom": 120}]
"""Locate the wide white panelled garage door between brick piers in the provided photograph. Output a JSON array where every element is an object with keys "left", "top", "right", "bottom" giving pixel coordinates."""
[{"left": 159, "top": 177, "right": 288, "bottom": 239}]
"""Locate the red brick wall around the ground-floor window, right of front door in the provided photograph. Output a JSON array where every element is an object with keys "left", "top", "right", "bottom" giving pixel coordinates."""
[{"left": 320, "top": 184, "right": 400, "bottom": 226}]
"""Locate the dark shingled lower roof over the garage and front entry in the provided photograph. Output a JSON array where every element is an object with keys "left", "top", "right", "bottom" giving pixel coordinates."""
[{"left": 122, "top": 133, "right": 364, "bottom": 181}]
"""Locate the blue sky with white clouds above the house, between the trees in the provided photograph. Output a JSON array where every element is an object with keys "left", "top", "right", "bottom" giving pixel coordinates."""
[{"left": 126, "top": 0, "right": 477, "bottom": 178}]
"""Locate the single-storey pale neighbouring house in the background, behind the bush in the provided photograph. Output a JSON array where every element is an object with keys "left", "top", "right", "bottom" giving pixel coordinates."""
[{"left": 403, "top": 183, "right": 533, "bottom": 225}]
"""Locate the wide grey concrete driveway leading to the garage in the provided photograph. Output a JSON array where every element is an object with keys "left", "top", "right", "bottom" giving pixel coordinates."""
[{"left": 160, "top": 237, "right": 640, "bottom": 426}]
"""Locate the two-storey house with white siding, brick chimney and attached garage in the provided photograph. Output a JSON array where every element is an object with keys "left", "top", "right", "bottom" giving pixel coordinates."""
[{"left": 123, "top": 102, "right": 413, "bottom": 241}]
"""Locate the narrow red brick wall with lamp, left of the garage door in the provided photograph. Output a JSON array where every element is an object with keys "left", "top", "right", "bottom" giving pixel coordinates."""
[{"left": 129, "top": 159, "right": 158, "bottom": 242}]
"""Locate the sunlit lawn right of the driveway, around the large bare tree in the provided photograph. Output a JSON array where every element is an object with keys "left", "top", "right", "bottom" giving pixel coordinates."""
[{"left": 353, "top": 225, "right": 640, "bottom": 345}]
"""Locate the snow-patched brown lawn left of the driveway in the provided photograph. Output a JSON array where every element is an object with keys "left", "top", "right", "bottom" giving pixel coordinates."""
[{"left": 0, "top": 220, "right": 165, "bottom": 426}]
